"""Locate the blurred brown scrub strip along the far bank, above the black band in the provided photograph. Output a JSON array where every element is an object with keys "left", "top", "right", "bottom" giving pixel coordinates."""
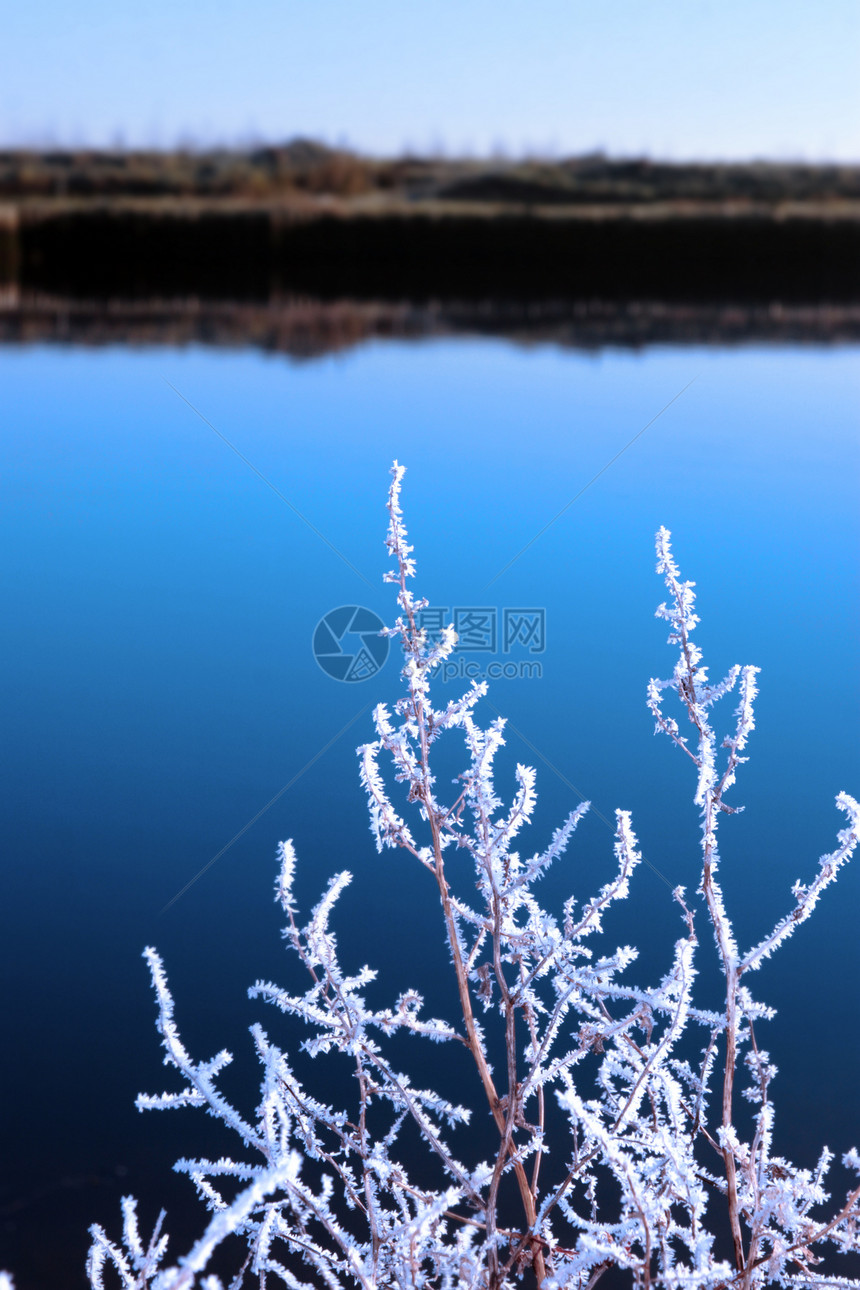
[{"left": 0, "top": 139, "right": 860, "bottom": 206}]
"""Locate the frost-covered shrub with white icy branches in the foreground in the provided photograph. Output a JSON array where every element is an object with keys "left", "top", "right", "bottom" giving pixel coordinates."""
[{"left": 77, "top": 463, "right": 860, "bottom": 1290}]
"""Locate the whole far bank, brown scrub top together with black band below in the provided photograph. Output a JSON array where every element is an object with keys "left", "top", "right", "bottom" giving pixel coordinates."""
[{"left": 0, "top": 139, "right": 860, "bottom": 306}]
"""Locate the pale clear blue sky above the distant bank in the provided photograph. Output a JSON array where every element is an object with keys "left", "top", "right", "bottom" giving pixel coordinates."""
[{"left": 0, "top": 0, "right": 860, "bottom": 161}]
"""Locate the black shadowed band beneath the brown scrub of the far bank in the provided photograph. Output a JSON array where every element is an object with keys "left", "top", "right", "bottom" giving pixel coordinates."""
[{"left": 6, "top": 203, "right": 860, "bottom": 304}]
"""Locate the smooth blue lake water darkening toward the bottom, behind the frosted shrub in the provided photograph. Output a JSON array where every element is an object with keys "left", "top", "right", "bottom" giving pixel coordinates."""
[{"left": 0, "top": 341, "right": 860, "bottom": 1290}]
